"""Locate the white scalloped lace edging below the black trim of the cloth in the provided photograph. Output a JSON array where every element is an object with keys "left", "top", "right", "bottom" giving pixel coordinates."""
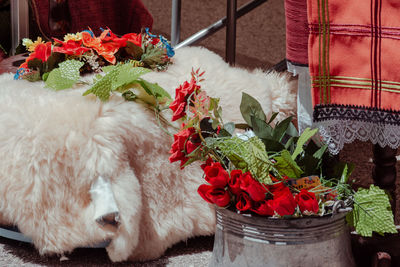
[{"left": 315, "top": 119, "right": 400, "bottom": 155}]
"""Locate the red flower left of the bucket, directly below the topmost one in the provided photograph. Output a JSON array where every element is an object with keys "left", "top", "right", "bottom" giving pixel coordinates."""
[{"left": 169, "top": 125, "right": 201, "bottom": 169}]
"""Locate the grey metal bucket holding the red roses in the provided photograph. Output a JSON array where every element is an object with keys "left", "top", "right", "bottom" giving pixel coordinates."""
[{"left": 210, "top": 209, "right": 355, "bottom": 267}]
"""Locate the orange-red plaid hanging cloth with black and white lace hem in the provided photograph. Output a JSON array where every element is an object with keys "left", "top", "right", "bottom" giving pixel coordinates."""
[{"left": 308, "top": 0, "right": 400, "bottom": 154}]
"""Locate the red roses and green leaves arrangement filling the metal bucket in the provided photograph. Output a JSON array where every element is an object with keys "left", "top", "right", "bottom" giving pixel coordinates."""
[{"left": 169, "top": 70, "right": 397, "bottom": 239}]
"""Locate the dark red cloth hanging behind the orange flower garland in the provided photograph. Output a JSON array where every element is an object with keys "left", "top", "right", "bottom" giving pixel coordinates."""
[{"left": 32, "top": 0, "right": 153, "bottom": 38}]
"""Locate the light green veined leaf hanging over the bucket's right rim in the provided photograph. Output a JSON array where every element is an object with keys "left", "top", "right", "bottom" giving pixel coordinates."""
[{"left": 349, "top": 185, "right": 397, "bottom": 236}]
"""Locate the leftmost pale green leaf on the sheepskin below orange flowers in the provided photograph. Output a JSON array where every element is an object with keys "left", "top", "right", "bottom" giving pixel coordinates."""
[{"left": 46, "top": 60, "right": 84, "bottom": 90}]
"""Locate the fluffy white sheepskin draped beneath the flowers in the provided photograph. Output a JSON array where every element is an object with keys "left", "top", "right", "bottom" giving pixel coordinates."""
[{"left": 0, "top": 47, "right": 296, "bottom": 261}]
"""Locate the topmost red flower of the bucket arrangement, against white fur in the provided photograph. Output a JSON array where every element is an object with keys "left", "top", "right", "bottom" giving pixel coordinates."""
[{"left": 169, "top": 78, "right": 200, "bottom": 121}]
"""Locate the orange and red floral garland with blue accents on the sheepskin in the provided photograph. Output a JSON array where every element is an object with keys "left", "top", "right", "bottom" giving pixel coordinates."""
[{"left": 14, "top": 28, "right": 174, "bottom": 81}]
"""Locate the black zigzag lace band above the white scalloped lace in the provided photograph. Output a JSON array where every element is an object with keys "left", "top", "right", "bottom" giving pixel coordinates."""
[{"left": 313, "top": 104, "right": 400, "bottom": 126}]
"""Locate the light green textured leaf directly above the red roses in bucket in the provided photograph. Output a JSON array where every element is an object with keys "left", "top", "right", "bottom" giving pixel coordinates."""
[{"left": 207, "top": 136, "right": 273, "bottom": 184}]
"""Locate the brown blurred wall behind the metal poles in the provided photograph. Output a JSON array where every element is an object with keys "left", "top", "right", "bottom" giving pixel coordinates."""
[{"left": 143, "top": 0, "right": 285, "bottom": 69}]
